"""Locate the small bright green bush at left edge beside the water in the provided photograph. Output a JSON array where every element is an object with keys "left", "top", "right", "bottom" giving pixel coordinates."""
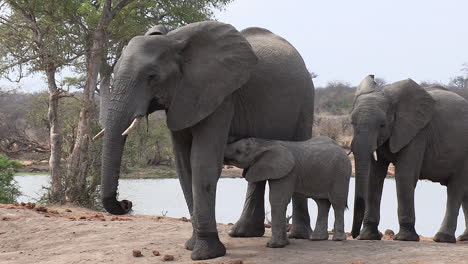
[{"left": 0, "top": 155, "right": 21, "bottom": 204}]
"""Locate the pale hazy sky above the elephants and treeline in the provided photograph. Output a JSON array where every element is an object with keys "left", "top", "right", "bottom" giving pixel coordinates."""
[{"left": 0, "top": 0, "right": 468, "bottom": 91}]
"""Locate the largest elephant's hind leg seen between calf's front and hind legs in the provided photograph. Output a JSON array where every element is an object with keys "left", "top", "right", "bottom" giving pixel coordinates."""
[{"left": 289, "top": 193, "right": 312, "bottom": 239}]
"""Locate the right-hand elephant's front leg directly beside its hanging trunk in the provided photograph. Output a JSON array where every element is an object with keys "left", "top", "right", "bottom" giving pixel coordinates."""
[{"left": 358, "top": 159, "right": 389, "bottom": 240}]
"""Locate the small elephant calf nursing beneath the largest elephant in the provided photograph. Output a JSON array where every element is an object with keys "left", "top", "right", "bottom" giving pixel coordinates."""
[{"left": 224, "top": 137, "right": 351, "bottom": 247}]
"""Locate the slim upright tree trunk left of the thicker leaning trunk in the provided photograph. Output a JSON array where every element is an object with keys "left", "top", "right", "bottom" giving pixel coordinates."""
[{"left": 46, "top": 67, "right": 63, "bottom": 202}]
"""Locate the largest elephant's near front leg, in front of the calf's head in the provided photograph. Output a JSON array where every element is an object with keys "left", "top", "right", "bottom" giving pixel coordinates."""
[{"left": 190, "top": 101, "right": 233, "bottom": 260}]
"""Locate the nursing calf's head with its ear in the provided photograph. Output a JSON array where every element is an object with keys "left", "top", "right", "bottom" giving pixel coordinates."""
[{"left": 224, "top": 138, "right": 295, "bottom": 182}]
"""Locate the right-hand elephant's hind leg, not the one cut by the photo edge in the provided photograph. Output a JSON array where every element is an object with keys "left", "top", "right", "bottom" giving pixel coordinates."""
[{"left": 434, "top": 175, "right": 465, "bottom": 243}]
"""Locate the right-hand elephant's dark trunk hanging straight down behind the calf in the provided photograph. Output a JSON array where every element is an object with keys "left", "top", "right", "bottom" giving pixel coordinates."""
[{"left": 351, "top": 135, "right": 373, "bottom": 238}]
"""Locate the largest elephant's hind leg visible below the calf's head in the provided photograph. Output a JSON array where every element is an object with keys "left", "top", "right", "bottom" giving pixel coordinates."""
[{"left": 229, "top": 179, "right": 266, "bottom": 237}]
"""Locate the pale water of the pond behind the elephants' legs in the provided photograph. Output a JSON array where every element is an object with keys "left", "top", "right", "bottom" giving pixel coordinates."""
[{"left": 15, "top": 175, "right": 465, "bottom": 236}]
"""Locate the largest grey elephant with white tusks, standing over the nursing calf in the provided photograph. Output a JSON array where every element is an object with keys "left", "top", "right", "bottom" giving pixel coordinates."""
[{"left": 101, "top": 21, "right": 314, "bottom": 260}]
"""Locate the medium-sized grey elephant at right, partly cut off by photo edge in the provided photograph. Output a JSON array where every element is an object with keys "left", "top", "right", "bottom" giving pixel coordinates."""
[{"left": 351, "top": 75, "right": 468, "bottom": 242}]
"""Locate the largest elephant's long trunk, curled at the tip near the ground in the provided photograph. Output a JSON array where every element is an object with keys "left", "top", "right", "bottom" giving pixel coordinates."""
[{"left": 101, "top": 76, "right": 134, "bottom": 215}]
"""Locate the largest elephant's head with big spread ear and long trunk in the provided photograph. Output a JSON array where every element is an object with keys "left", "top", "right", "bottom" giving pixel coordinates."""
[{"left": 101, "top": 22, "right": 257, "bottom": 214}]
